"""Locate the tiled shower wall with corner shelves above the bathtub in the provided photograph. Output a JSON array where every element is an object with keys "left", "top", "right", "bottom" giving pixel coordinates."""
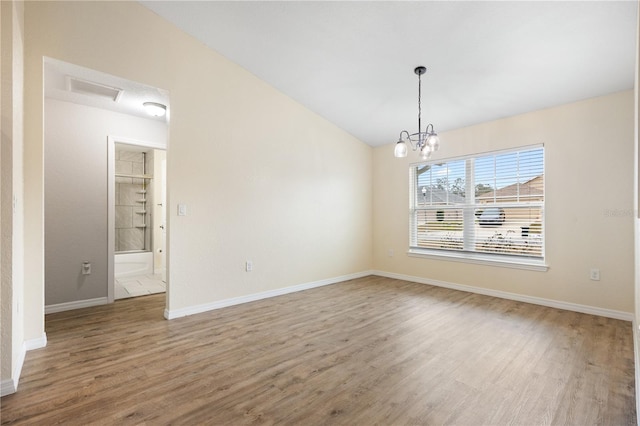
[{"left": 115, "top": 145, "right": 153, "bottom": 252}]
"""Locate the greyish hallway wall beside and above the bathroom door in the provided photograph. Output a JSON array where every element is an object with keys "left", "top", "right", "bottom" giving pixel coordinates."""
[{"left": 44, "top": 99, "right": 167, "bottom": 306}]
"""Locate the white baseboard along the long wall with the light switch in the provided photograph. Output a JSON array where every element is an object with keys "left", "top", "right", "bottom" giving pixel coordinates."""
[{"left": 164, "top": 271, "right": 372, "bottom": 320}]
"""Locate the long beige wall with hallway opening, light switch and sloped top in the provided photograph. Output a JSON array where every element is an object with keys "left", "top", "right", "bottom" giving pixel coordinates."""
[{"left": 25, "top": 2, "right": 372, "bottom": 326}]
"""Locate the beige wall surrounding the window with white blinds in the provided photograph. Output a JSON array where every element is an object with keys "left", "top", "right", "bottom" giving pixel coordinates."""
[{"left": 373, "top": 91, "right": 634, "bottom": 313}]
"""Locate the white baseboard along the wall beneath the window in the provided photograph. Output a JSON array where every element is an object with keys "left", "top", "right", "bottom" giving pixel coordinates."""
[{"left": 372, "top": 271, "right": 633, "bottom": 321}]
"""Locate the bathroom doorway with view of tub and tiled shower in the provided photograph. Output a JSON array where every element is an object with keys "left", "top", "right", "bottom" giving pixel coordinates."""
[{"left": 108, "top": 136, "right": 166, "bottom": 302}]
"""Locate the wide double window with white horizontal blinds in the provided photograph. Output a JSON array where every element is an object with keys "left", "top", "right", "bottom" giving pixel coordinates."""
[{"left": 410, "top": 146, "right": 544, "bottom": 265}]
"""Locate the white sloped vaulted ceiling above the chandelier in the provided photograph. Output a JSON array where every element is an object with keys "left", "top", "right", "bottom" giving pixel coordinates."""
[{"left": 141, "top": 1, "right": 637, "bottom": 146}]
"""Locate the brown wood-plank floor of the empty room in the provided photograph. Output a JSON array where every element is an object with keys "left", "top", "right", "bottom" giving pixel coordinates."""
[{"left": 0, "top": 277, "right": 636, "bottom": 425}]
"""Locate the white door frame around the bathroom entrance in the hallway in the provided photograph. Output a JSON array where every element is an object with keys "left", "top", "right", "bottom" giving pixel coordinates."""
[{"left": 107, "top": 135, "right": 168, "bottom": 303}]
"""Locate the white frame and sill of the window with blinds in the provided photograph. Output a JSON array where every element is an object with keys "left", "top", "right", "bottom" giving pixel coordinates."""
[{"left": 407, "top": 144, "right": 549, "bottom": 271}]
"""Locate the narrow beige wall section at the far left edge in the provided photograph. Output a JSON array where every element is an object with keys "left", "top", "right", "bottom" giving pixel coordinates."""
[{"left": 0, "top": 1, "right": 24, "bottom": 395}]
